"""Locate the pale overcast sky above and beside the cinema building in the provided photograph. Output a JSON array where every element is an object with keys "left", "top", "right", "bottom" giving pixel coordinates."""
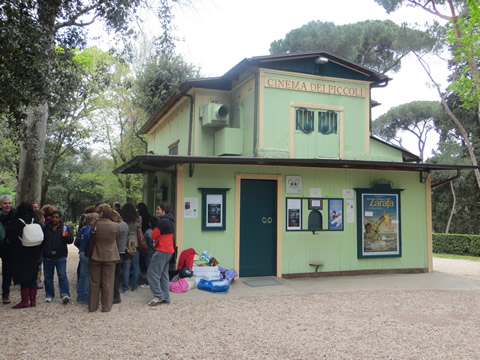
[{"left": 91, "top": 0, "right": 447, "bottom": 158}]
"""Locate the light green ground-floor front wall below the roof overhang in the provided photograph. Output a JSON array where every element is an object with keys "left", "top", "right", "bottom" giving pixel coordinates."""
[{"left": 180, "top": 165, "right": 427, "bottom": 274}]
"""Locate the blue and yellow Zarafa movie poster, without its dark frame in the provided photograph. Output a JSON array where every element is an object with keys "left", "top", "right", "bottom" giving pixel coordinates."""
[{"left": 362, "top": 193, "right": 400, "bottom": 256}]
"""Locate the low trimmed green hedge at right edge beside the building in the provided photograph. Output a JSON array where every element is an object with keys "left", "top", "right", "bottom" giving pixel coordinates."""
[{"left": 433, "top": 234, "right": 480, "bottom": 256}]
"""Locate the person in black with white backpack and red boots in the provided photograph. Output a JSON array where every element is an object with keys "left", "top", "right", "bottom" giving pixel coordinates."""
[{"left": 8, "top": 201, "right": 43, "bottom": 309}]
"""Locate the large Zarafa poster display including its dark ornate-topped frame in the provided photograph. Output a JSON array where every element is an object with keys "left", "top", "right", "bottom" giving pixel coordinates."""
[{"left": 356, "top": 185, "right": 401, "bottom": 258}]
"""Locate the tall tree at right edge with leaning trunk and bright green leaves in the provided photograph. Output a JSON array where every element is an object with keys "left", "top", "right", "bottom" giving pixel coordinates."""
[{"left": 375, "top": 0, "right": 480, "bottom": 189}]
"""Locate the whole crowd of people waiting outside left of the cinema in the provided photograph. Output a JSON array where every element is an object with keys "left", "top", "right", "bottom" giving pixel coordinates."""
[{"left": 0, "top": 195, "right": 175, "bottom": 312}]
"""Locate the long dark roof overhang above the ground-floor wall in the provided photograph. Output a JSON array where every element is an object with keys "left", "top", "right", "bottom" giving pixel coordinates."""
[{"left": 114, "top": 154, "right": 478, "bottom": 174}]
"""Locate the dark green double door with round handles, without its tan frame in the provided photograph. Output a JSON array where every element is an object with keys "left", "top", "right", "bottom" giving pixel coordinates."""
[{"left": 240, "top": 180, "right": 277, "bottom": 276}]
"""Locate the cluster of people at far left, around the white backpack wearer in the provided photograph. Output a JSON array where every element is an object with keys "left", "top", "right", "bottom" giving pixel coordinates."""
[{"left": 0, "top": 195, "right": 73, "bottom": 309}]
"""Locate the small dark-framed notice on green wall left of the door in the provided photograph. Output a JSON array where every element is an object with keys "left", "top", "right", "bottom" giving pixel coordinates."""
[{"left": 200, "top": 188, "right": 228, "bottom": 230}]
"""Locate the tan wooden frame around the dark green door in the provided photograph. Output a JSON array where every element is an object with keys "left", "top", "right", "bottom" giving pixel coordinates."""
[{"left": 234, "top": 173, "right": 284, "bottom": 277}]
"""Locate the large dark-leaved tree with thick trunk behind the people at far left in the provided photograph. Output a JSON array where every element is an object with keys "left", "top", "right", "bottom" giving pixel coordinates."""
[{"left": 0, "top": 0, "right": 173, "bottom": 201}]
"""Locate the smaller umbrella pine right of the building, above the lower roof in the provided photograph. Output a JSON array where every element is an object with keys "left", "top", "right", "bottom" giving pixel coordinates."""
[{"left": 373, "top": 101, "right": 442, "bottom": 160}]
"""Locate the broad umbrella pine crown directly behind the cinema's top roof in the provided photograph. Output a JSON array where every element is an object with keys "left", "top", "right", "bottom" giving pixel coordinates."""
[{"left": 270, "top": 20, "right": 436, "bottom": 73}]
